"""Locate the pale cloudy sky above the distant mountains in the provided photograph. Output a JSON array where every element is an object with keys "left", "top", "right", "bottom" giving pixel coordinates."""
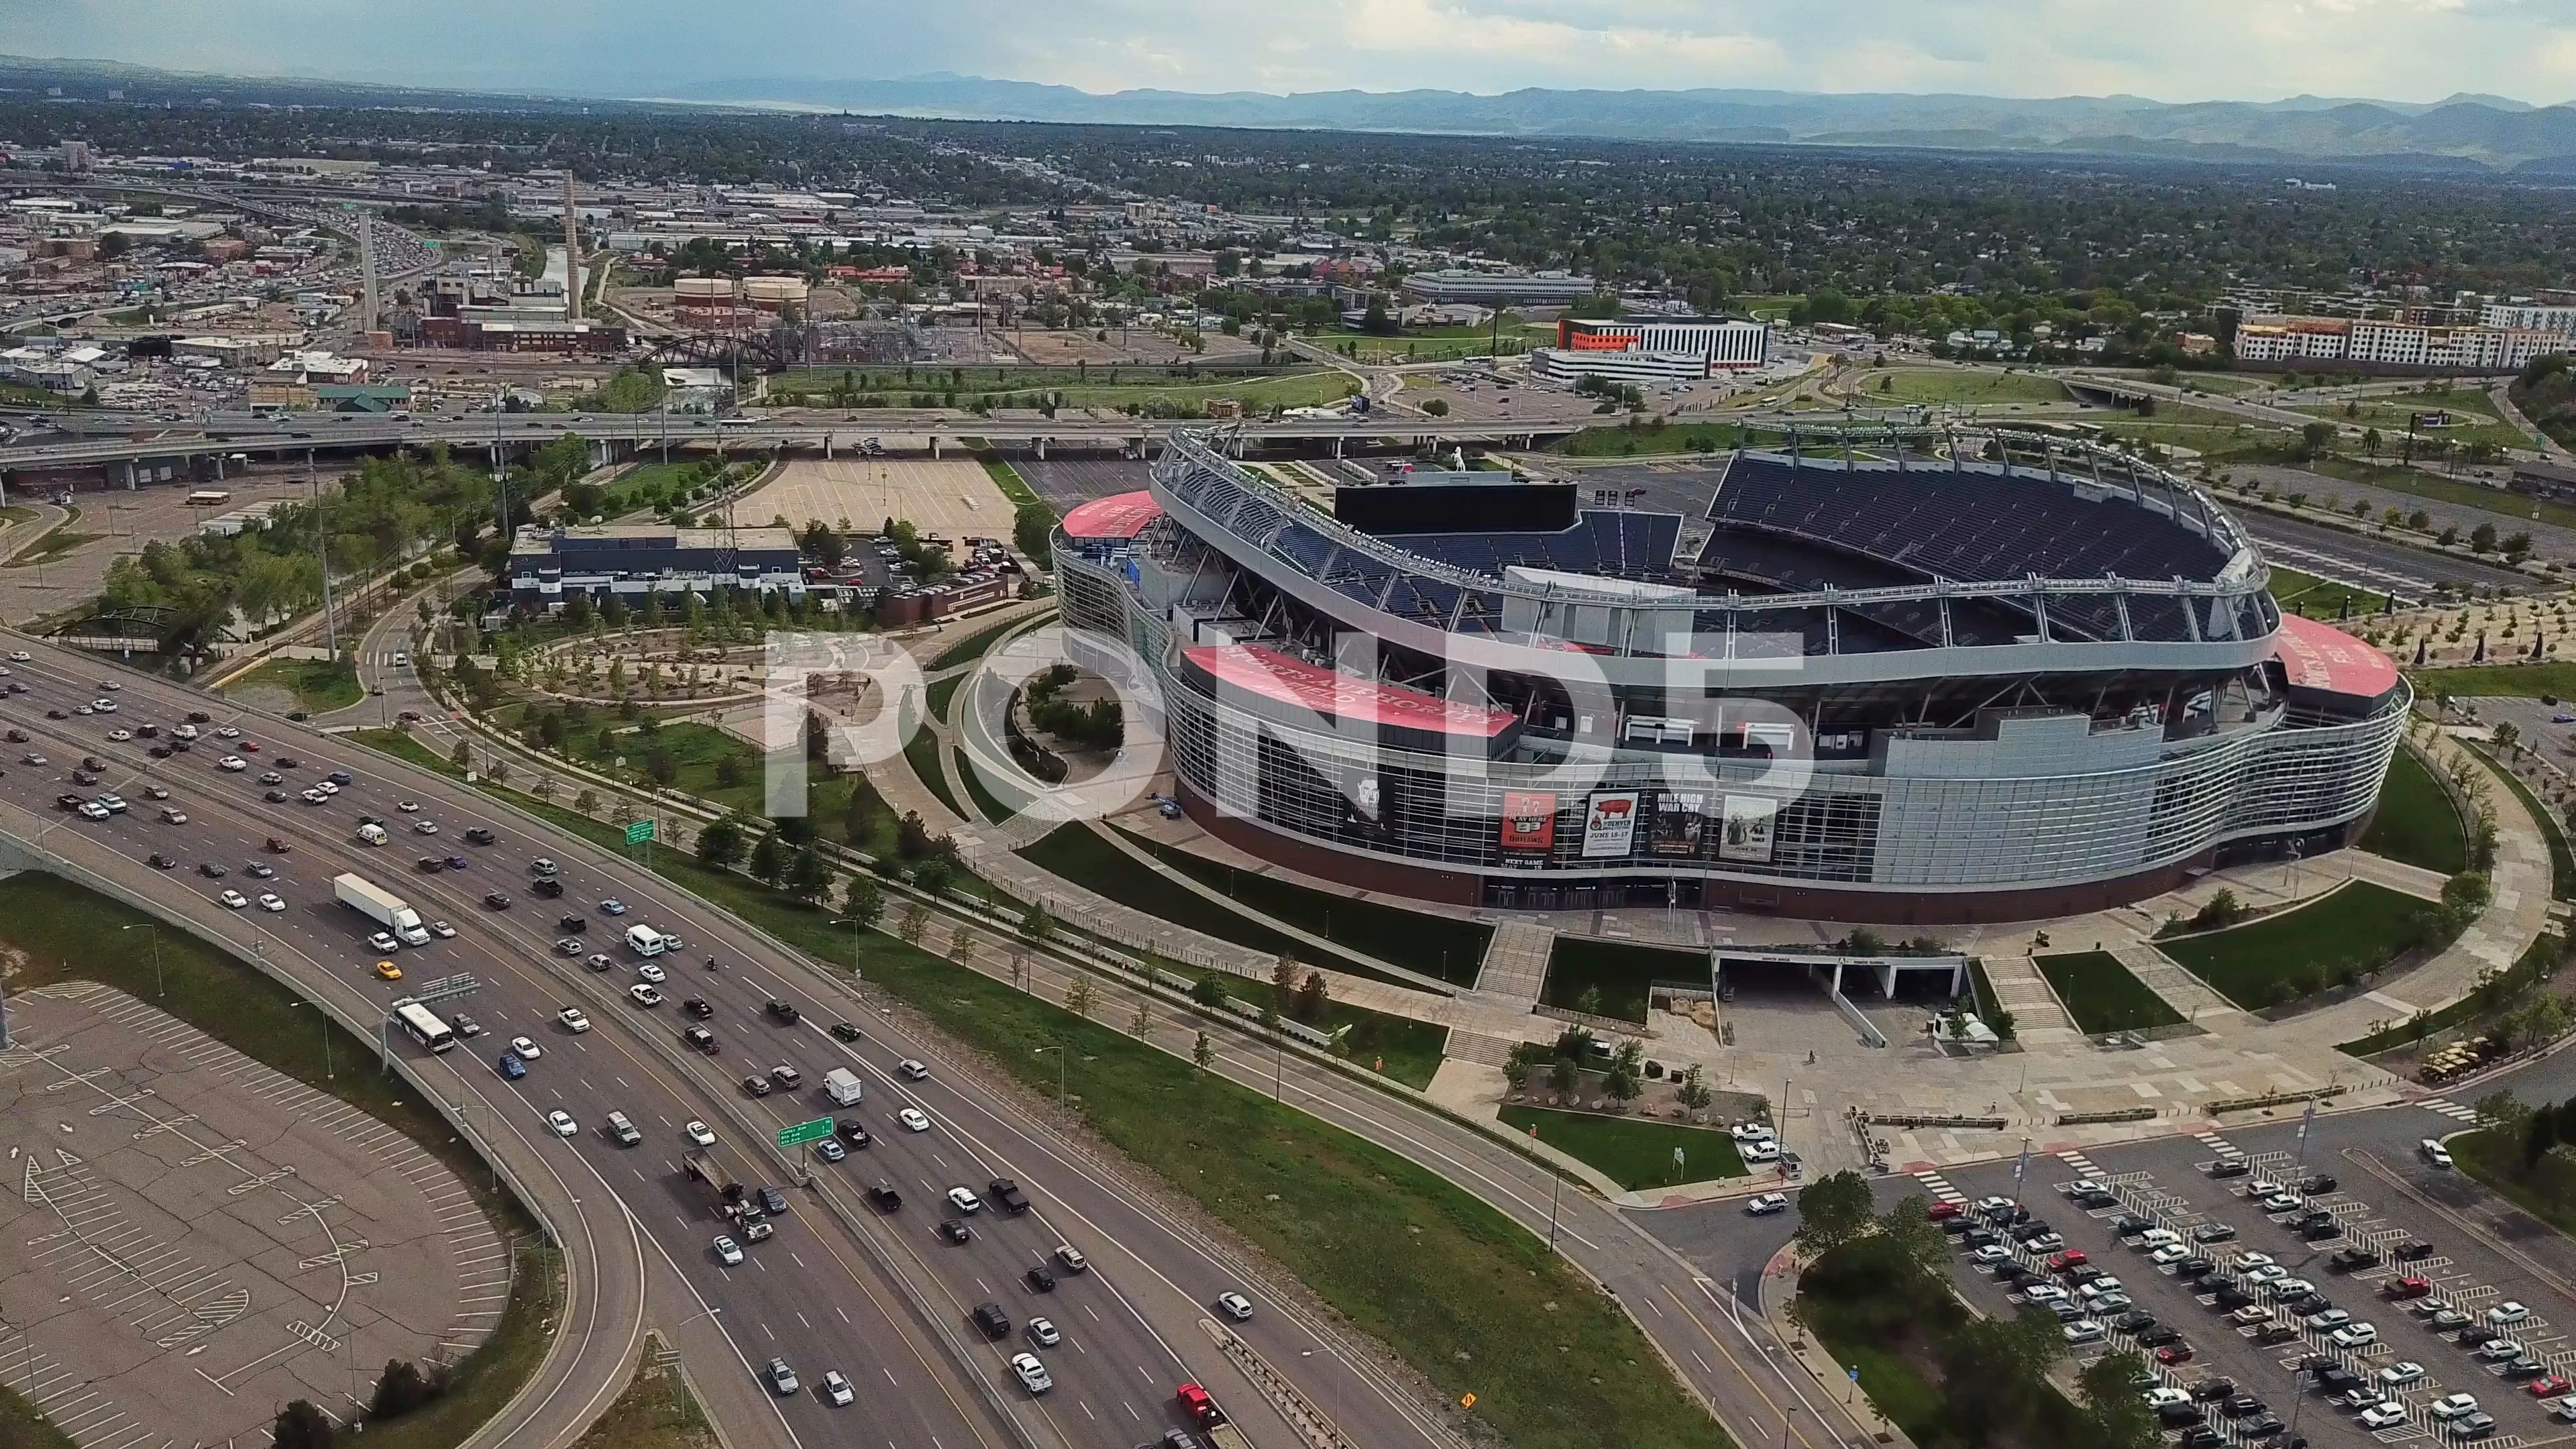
[{"left": 0, "top": 0, "right": 2576, "bottom": 106}]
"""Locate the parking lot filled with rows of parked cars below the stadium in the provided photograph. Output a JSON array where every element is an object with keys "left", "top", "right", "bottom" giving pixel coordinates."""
[{"left": 1919, "top": 1104, "right": 2576, "bottom": 1446}]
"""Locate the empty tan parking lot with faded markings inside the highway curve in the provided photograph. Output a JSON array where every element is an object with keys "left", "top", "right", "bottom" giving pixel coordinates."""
[{"left": 0, "top": 982, "right": 510, "bottom": 1449}]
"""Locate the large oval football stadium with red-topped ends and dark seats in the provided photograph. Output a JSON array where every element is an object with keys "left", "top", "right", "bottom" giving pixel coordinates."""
[{"left": 1056, "top": 431, "right": 2408, "bottom": 923}]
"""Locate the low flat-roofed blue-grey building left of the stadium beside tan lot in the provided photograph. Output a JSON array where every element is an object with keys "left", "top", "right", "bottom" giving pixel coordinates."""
[{"left": 510, "top": 523, "right": 804, "bottom": 608}]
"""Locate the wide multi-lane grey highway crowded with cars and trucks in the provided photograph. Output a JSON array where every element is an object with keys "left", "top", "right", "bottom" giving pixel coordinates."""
[{"left": 0, "top": 639, "right": 1435, "bottom": 1449}]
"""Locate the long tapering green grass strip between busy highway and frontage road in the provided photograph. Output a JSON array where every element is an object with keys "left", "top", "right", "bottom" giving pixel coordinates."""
[{"left": 342, "top": 735, "right": 1723, "bottom": 1449}]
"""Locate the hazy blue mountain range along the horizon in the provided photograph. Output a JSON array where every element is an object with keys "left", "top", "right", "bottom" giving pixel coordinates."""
[{"left": 665, "top": 74, "right": 2576, "bottom": 173}]
